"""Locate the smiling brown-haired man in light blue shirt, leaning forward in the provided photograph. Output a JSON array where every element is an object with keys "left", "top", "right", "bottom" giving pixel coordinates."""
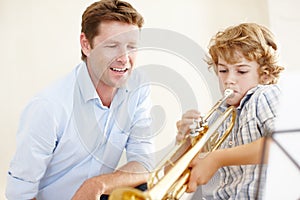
[{"left": 6, "top": 0, "right": 153, "bottom": 199}]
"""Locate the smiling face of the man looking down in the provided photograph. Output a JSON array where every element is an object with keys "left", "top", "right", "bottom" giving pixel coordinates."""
[{"left": 87, "top": 21, "right": 139, "bottom": 88}]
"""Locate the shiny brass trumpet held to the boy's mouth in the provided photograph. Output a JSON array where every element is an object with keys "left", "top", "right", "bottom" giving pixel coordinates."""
[{"left": 109, "top": 89, "right": 236, "bottom": 200}]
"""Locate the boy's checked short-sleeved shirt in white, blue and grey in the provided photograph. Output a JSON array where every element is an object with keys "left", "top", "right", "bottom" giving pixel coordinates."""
[{"left": 214, "top": 85, "right": 280, "bottom": 200}]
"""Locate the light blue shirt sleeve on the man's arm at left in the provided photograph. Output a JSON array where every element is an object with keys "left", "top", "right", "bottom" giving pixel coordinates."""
[{"left": 6, "top": 98, "right": 57, "bottom": 199}]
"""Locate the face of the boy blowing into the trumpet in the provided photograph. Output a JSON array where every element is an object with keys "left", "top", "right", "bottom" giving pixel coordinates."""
[{"left": 217, "top": 52, "right": 259, "bottom": 107}]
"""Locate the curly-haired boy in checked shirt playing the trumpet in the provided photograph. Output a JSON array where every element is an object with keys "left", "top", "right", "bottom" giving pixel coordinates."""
[{"left": 177, "top": 23, "right": 283, "bottom": 199}]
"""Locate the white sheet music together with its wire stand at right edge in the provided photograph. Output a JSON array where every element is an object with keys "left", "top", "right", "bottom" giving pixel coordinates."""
[{"left": 259, "top": 73, "right": 300, "bottom": 200}]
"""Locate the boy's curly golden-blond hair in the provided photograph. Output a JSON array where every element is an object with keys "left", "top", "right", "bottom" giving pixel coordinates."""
[{"left": 206, "top": 23, "right": 284, "bottom": 84}]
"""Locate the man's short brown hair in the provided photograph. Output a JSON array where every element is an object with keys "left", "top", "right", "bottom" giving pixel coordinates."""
[{"left": 81, "top": 0, "right": 144, "bottom": 60}]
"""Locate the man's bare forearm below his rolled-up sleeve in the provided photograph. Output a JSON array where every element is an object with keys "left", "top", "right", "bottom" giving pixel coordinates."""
[{"left": 72, "top": 162, "right": 149, "bottom": 200}]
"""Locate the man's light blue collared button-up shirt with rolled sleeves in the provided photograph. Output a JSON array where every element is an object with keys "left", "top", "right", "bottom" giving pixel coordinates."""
[{"left": 6, "top": 62, "right": 154, "bottom": 200}]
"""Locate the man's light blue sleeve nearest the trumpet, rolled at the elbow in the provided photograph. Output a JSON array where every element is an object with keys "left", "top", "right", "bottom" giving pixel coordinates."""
[{"left": 126, "top": 85, "right": 154, "bottom": 171}]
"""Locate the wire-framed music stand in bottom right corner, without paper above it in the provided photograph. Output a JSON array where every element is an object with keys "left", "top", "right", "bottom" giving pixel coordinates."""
[{"left": 264, "top": 129, "right": 300, "bottom": 200}]
